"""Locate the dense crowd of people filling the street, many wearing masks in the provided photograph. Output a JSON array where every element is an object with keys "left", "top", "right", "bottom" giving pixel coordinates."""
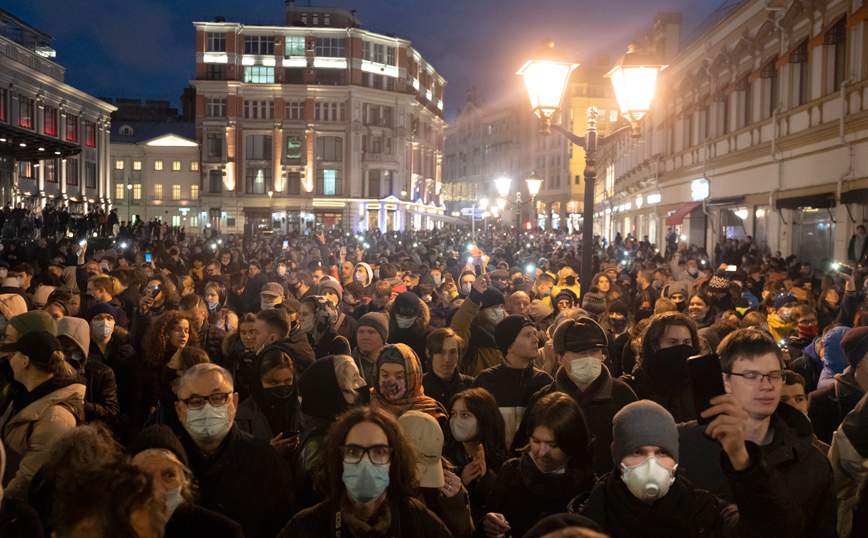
[{"left": 0, "top": 221, "right": 868, "bottom": 538}]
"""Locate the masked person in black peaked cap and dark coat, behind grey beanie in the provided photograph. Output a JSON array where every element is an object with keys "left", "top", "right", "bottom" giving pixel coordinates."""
[{"left": 512, "top": 318, "right": 637, "bottom": 476}]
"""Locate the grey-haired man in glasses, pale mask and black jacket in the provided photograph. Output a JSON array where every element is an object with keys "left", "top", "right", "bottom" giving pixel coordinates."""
[{"left": 175, "top": 363, "right": 294, "bottom": 538}]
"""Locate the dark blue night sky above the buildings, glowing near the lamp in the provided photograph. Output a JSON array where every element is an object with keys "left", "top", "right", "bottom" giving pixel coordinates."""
[{"left": 13, "top": 0, "right": 723, "bottom": 120}]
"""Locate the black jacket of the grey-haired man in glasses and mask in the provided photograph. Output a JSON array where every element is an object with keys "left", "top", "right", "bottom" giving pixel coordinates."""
[{"left": 181, "top": 425, "right": 293, "bottom": 538}]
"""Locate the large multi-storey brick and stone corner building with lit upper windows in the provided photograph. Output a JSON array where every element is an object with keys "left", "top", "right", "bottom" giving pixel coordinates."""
[{"left": 191, "top": 1, "right": 449, "bottom": 233}]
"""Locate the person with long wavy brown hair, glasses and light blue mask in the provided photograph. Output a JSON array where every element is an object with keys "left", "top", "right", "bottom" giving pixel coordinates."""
[{"left": 279, "top": 407, "right": 451, "bottom": 538}]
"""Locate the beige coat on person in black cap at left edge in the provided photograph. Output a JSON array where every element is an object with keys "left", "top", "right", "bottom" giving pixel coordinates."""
[{"left": 0, "top": 383, "right": 85, "bottom": 501}]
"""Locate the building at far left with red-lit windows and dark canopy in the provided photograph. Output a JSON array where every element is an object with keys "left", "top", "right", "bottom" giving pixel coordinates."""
[{"left": 0, "top": 10, "right": 115, "bottom": 213}]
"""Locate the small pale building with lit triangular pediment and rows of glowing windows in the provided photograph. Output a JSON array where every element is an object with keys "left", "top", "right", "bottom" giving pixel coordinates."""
[{"left": 110, "top": 122, "right": 207, "bottom": 236}]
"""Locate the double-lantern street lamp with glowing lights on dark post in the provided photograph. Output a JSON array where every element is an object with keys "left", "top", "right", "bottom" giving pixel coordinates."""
[{"left": 516, "top": 39, "right": 666, "bottom": 295}]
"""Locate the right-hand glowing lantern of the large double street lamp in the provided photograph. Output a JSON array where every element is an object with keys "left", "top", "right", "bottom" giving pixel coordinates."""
[{"left": 605, "top": 45, "right": 667, "bottom": 138}]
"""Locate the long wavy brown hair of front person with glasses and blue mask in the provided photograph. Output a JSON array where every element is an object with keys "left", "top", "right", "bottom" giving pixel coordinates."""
[{"left": 311, "top": 406, "right": 419, "bottom": 505}]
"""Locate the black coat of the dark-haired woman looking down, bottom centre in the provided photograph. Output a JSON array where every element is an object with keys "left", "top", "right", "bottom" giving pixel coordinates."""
[{"left": 475, "top": 453, "right": 596, "bottom": 538}]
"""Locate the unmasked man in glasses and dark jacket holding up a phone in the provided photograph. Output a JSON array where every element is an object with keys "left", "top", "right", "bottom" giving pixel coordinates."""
[{"left": 678, "top": 329, "right": 837, "bottom": 537}]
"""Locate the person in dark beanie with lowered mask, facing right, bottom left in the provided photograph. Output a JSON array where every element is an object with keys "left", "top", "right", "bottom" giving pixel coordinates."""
[{"left": 128, "top": 424, "right": 241, "bottom": 538}]
